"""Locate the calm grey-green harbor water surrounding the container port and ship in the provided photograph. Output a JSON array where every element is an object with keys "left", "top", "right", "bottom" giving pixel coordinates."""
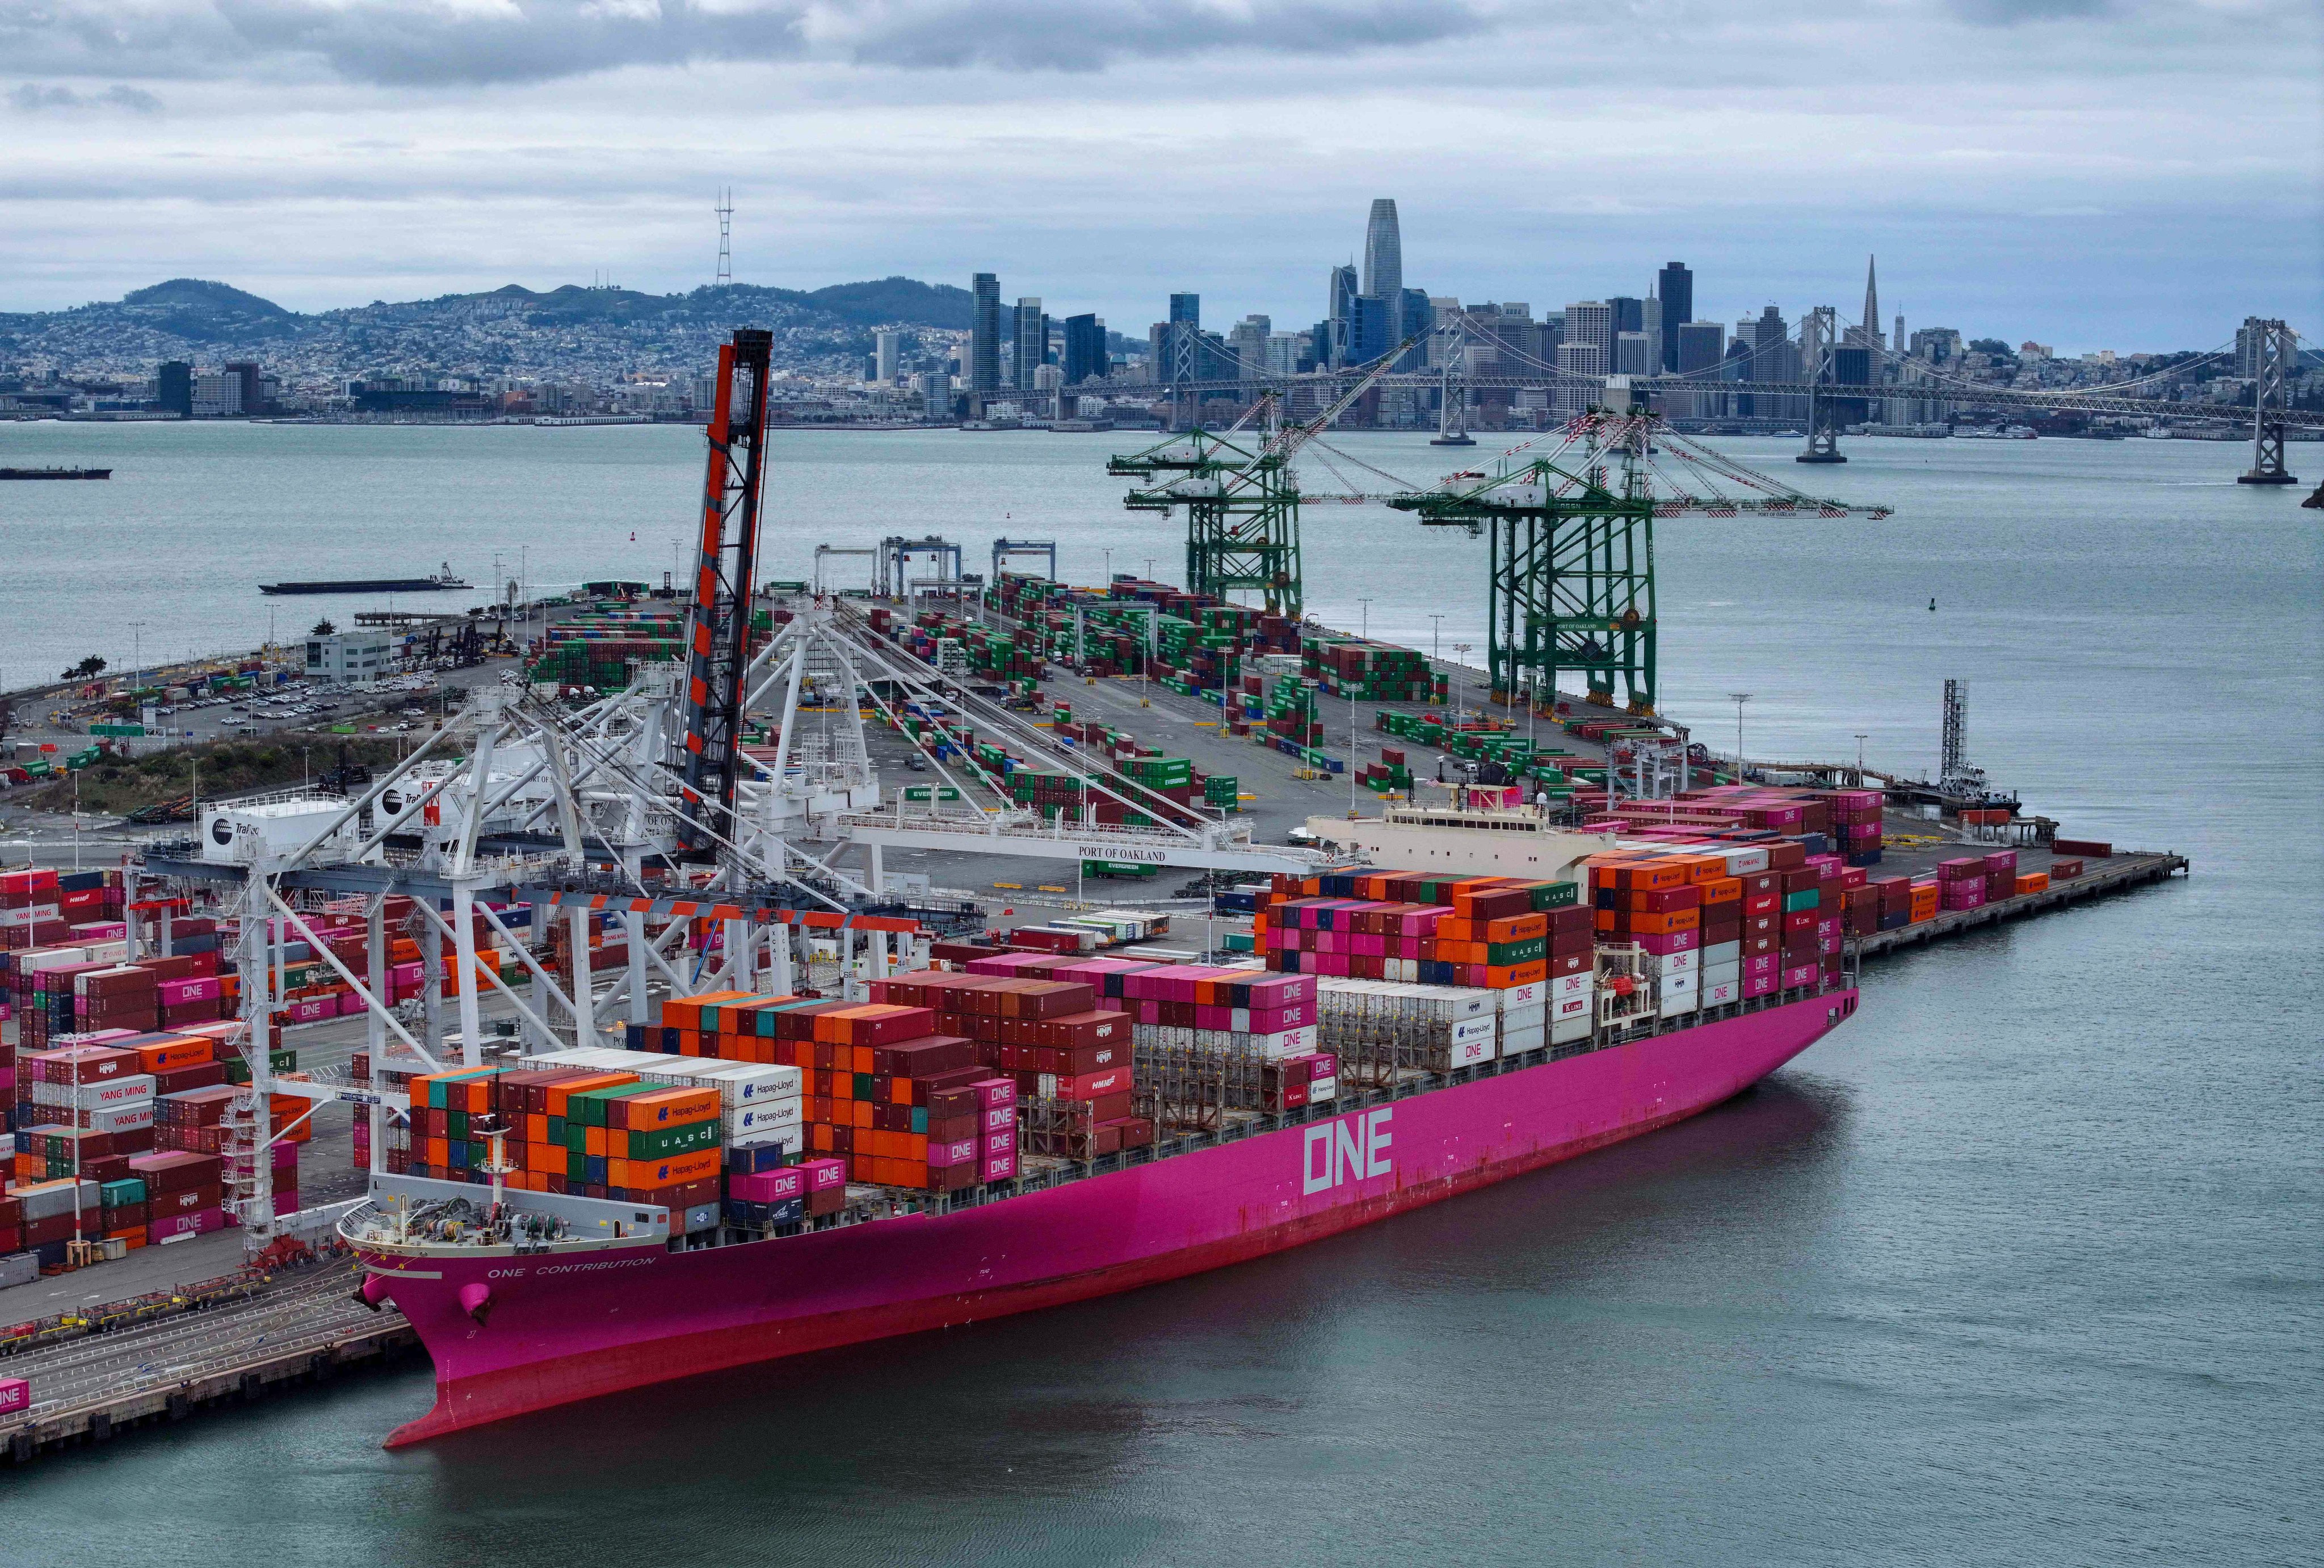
[{"left": 0, "top": 423, "right": 2324, "bottom": 1568}]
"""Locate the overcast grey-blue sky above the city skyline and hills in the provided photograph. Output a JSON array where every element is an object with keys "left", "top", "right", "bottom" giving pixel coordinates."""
[{"left": 0, "top": 0, "right": 2324, "bottom": 351}]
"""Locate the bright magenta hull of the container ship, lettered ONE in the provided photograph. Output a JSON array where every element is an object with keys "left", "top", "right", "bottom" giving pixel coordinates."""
[{"left": 363, "top": 990, "right": 1857, "bottom": 1447}]
